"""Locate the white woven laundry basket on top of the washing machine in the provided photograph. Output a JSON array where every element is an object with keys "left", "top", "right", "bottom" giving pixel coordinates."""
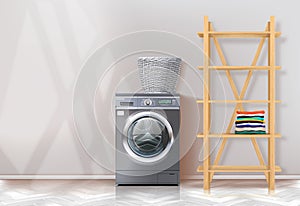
[{"left": 138, "top": 57, "right": 181, "bottom": 93}]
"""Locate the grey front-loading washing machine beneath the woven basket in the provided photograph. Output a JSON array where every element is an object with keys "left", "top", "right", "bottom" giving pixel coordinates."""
[{"left": 115, "top": 93, "right": 180, "bottom": 185}]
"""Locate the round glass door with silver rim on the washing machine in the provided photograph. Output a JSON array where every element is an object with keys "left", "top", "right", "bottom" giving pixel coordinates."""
[{"left": 123, "top": 111, "right": 174, "bottom": 163}]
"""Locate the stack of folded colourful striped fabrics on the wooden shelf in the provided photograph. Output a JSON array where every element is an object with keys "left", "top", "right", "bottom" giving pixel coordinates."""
[{"left": 235, "top": 110, "right": 266, "bottom": 134}]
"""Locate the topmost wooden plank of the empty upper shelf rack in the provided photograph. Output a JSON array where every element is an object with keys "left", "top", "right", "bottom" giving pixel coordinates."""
[{"left": 198, "top": 31, "right": 281, "bottom": 38}]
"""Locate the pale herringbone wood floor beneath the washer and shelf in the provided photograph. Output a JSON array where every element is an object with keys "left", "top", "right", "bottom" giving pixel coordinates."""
[{"left": 0, "top": 180, "right": 300, "bottom": 206}]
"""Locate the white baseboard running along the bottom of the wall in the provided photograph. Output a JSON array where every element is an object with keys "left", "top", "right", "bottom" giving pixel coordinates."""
[{"left": 0, "top": 175, "right": 300, "bottom": 180}]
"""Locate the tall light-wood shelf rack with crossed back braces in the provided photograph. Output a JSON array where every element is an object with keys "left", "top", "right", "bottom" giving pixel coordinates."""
[{"left": 197, "top": 16, "right": 281, "bottom": 193}]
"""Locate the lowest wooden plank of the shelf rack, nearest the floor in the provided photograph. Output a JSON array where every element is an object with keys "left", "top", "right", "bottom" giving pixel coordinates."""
[{"left": 197, "top": 165, "right": 281, "bottom": 172}]
